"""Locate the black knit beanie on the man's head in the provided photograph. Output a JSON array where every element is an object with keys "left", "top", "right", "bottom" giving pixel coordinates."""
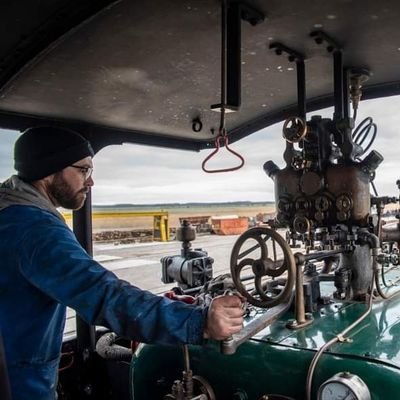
[{"left": 14, "top": 126, "right": 94, "bottom": 182}]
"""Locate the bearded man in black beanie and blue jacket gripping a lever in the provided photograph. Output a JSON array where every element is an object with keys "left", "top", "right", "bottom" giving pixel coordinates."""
[{"left": 0, "top": 127, "right": 243, "bottom": 400}]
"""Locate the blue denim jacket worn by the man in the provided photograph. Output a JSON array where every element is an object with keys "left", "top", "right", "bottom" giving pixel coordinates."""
[{"left": 0, "top": 205, "right": 205, "bottom": 400}]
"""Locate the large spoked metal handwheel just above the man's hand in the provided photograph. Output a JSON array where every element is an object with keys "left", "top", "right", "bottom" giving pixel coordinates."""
[{"left": 231, "top": 226, "right": 296, "bottom": 307}]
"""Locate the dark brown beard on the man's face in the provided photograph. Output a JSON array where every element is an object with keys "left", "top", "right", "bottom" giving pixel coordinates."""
[{"left": 48, "top": 173, "right": 88, "bottom": 210}]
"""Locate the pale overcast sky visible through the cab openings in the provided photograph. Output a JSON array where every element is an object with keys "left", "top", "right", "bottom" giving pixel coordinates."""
[{"left": 0, "top": 96, "right": 400, "bottom": 204}]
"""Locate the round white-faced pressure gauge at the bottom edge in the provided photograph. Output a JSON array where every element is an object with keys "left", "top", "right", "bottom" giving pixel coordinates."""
[{"left": 318, "top": 372, "right": 371, "bottom": 400}]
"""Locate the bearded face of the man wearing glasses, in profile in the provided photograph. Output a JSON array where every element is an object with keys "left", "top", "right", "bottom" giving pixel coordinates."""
[{"left": 47, "top": 157, "right": 94, "bottom": 210}]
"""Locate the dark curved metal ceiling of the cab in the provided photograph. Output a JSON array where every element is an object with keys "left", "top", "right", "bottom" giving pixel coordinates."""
[{"left": 0, "top": 0, "right": 400, "bottom": 150}]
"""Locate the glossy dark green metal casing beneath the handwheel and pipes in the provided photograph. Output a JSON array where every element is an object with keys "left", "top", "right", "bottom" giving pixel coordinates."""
[{"left": 131, "top": 298, "right": 400, "bottom": 400}]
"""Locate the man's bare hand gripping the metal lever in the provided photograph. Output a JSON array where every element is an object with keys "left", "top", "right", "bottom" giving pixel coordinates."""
[{"left": 204, "top": 295, "right": 243, "bottom": 340}]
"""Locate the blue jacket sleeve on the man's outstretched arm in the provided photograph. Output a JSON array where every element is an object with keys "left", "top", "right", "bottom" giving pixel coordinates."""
[{"left": 19, "top": 217, "right": 207, "bottom": 344}]
